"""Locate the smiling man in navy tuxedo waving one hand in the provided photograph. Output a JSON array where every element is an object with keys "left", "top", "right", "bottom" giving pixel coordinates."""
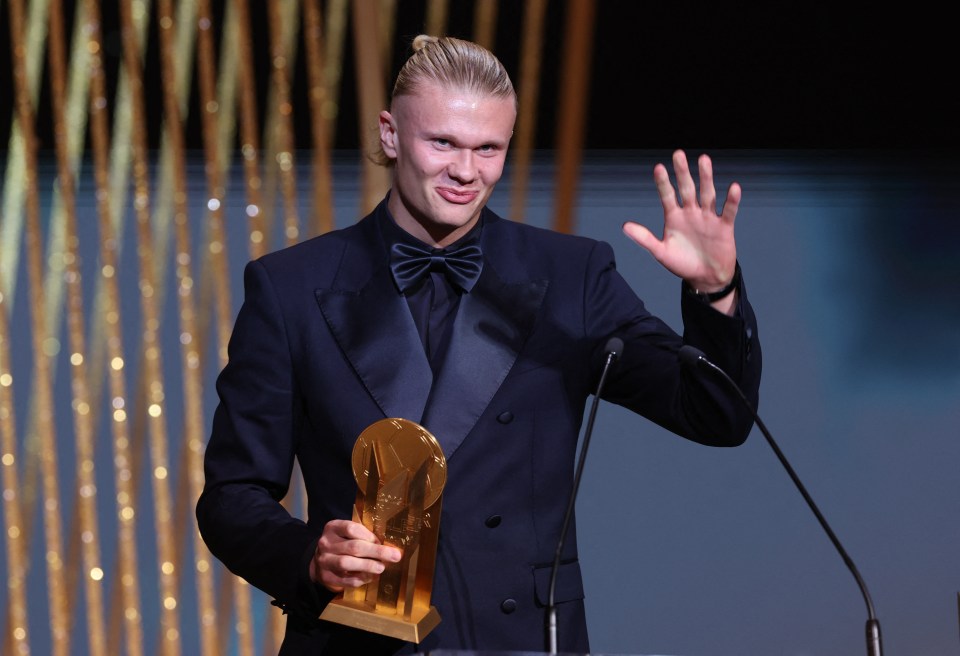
[{"left": 197, "top": 36, "right": 760, "bottom": 654}]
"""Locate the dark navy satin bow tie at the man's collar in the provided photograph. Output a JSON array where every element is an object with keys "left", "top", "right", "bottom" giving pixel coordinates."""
[{"left": 390, "top": 241, "right": 483, "bottom": 292}]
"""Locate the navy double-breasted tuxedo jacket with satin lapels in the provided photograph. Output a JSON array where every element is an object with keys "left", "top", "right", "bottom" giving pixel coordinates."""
[{"left": 197, "top": 203, "right": 760, "bottom": 654}]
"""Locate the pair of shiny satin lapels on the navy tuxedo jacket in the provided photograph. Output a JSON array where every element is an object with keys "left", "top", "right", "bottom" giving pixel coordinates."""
[{"left": 315, "top": 208, "right": 548, "bottom": 458}]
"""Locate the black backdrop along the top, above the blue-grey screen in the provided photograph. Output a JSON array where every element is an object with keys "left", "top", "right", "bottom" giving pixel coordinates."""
[{"left": 0, "top": 0, "right": 960, "bottom": 150}]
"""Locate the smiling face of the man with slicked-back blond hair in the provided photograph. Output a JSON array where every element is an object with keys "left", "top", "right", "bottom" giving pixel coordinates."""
[{"left": 380, "top": 84, "right": 517, "bottom": 247}]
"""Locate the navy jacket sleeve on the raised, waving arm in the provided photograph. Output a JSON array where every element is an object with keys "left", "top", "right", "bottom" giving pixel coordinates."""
[{"left": 585, "top": 242, "right": 761, "bottom": 446}]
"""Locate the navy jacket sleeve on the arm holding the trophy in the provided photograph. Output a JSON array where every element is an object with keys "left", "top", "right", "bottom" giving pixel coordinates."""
[{"left": 196, "top": 261, "right": 325, "bottom": 617}]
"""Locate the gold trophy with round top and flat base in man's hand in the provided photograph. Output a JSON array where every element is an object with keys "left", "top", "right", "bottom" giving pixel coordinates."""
[{"left": 320, "top": 419, "right": 447, "bottom": 642}]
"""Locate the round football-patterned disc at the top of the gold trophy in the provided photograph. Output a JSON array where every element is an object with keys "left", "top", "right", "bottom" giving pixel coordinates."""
[{"left": 352, "top": 418, "right": 447, "bottom": 508}]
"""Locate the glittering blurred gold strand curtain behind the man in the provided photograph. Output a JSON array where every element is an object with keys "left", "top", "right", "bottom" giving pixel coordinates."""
[{"left": 0, "top": 0, "right": 594, "bottom": 656}]
